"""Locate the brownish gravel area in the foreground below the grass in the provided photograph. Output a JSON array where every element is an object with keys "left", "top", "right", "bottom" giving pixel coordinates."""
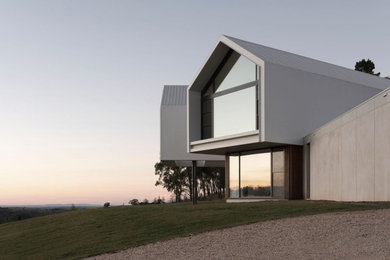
[{"left": 85, "top": 209, "right": 390, "bottom": 260}]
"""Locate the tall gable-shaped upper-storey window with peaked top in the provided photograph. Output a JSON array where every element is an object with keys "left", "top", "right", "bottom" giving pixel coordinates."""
[{"left": 202, "top": 51, "right": 259, "bottom": 139}]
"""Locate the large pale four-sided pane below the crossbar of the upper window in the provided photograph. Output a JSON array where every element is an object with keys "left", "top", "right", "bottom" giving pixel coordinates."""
[{"left": 214, "top": 86, "right": 256, "bottom": 137}]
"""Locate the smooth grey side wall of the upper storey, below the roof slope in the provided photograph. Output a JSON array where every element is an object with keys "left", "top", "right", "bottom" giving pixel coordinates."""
[{"left": 264, "top": 62, "right": 390, "bottom": 145}]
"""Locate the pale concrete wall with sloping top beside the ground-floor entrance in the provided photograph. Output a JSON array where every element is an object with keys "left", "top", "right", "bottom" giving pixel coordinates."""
[{"left": 304, "top": 89, "right": 390, "bottom": 201}]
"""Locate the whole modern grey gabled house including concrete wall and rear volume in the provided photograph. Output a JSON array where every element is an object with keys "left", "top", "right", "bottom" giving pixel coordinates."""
[{"left": 161, "top": 36, "right": 390, "bottom": 202}]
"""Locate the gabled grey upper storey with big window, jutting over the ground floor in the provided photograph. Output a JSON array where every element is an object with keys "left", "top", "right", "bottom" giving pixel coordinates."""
[{"left": 187, "top": 36, "right": 390, "bottom": 154}]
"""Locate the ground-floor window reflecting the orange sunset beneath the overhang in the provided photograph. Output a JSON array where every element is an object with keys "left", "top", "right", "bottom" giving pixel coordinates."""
[{"left": 229, "top": 149, "right": 285, "bottom": 199}]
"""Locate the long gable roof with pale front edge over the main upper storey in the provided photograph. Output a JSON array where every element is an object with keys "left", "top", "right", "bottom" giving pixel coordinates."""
[{"left": 189, "top": 35, "right": 390, "bottom": 91}]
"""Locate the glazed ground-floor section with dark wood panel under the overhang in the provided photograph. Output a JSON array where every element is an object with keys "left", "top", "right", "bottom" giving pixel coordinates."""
[{"left": 225, "top": 145, "right": 303, "bottom": 202}]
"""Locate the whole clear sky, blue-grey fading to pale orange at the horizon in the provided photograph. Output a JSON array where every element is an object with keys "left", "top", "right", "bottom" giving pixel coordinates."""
[{"left": 0, "top": 0, "right": 390, "bottom": 205}]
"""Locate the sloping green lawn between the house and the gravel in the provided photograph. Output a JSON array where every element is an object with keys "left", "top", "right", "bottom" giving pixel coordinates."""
[{"left": 0, "top": 201, "right": 389, "bottom": 259}]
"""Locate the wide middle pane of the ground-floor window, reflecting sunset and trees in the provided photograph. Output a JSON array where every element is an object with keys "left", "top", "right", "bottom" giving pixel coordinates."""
[{"left": 241, "top": 153, "right": 271, "bottom": 197}]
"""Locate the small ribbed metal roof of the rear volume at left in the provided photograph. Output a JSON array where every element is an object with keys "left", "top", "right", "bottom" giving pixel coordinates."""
[{"left": 161, "top": 85, "right": 188, "bottom": 106}]
